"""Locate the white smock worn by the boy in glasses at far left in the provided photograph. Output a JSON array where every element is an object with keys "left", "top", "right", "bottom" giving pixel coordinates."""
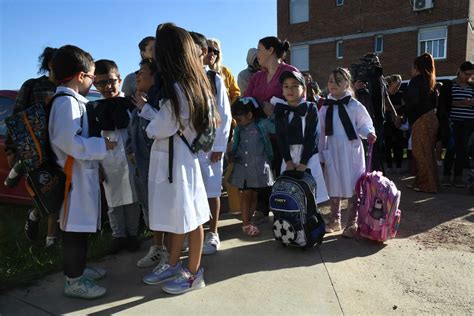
[{"left": 49, "top": 86, "right": 106, "bottom": 233}]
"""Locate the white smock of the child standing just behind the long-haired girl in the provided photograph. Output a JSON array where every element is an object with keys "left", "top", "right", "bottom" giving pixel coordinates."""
[{"left": 198, "top": 70, "right": 232, "bottom": 198}]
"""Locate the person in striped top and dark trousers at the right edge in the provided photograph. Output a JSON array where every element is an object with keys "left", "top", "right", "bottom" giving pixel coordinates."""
[{"left": 442, "top": 61, "right": 474, "bottom": 188}]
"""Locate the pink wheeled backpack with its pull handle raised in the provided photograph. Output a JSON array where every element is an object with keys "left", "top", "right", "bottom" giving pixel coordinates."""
[{"left": 355, "top": 144, "right": 401, "bottom": 242}]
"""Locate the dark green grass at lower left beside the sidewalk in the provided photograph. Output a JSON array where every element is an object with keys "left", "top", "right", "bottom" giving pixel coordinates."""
[{"left": 0, "top": 204, "right": 151, "bottom": 291}]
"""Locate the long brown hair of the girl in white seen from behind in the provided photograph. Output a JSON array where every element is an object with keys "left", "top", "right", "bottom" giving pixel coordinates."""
[{"left": 155, "top": 23, "right": 218, "bottom": 133}]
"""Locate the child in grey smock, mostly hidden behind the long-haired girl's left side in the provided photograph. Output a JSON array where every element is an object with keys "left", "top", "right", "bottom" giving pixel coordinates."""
[{"left": 127, "top": 58, "right": 169, "bottom": 268}]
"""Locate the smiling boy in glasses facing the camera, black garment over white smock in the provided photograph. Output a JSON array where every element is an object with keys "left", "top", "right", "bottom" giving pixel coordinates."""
[{"left": 94, "top": 59, "right": 140, "bottom": 253}]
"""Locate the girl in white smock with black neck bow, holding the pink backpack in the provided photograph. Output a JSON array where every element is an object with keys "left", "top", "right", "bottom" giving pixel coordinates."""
[{"left": 319, "top": 68, "right": 377, "bottom": 238}]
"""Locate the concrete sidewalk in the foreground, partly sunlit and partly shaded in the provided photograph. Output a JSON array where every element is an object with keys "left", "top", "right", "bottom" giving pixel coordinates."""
[{"left": 0, "top": 214, "right": 474, "bottom": 316}]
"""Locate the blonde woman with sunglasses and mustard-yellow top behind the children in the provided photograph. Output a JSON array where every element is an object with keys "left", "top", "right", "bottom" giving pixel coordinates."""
[{"left": 204, "top": 38, "right": 240, "bottom": 104}]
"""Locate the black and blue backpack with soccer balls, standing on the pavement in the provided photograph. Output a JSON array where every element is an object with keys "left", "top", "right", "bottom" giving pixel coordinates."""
[{"left": 270, "top": 169, "right": 326, "bottom": 248}]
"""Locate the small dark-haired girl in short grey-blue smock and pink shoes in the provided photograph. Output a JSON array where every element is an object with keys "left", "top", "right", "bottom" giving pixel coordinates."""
[{"left": 229, "top": 97, "right": 275, "bottom": 237}]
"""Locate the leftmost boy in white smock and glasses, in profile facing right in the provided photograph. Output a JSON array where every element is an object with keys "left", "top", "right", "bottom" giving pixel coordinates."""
[{"left": 49, "top": 45, "right": 116, "bottom": 299}]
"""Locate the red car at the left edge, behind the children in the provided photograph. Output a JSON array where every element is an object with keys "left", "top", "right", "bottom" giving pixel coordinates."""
[{"left": 0, "top": 90, "right": 101, "bottom": 204}]
